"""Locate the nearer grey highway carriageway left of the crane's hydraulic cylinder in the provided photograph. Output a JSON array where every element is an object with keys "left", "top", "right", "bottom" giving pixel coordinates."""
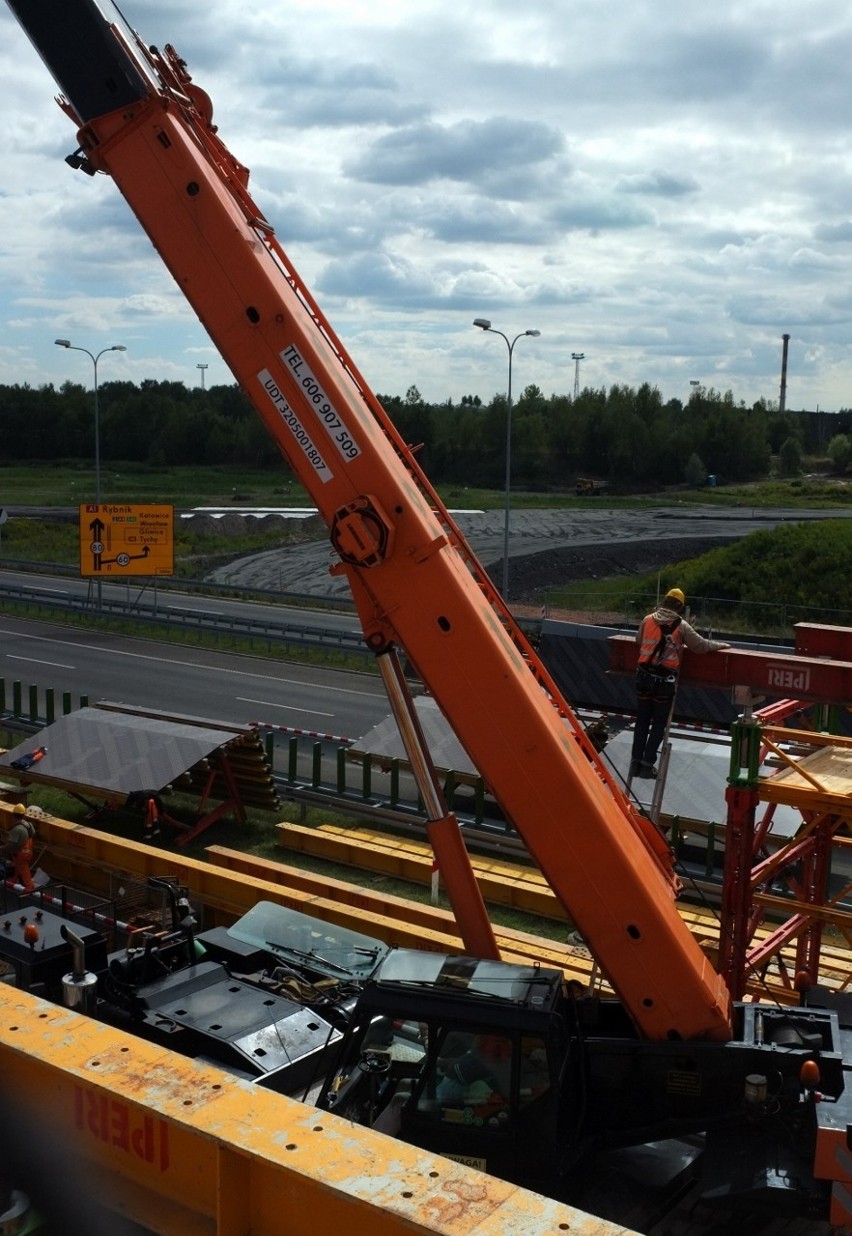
[{"left": 0, "top": 614, "right": 390, "bottom": 738}]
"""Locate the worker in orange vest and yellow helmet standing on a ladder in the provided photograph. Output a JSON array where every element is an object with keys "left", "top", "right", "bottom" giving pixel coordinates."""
[{"left": 629, "top": 588, "right": 731, "bottom": 780}]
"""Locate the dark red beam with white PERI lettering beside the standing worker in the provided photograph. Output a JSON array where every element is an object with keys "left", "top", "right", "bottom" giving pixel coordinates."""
[{"left": 608, "top": 633, "right": 852, "bottom": 703}]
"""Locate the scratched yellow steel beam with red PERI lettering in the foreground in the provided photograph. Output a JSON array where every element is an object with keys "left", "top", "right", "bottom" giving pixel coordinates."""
[{"left": 0, "top": 984, "right": 626, "bottom": 1236}]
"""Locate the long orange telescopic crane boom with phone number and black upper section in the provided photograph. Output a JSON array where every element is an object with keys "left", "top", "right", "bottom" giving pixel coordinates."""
[{"left": 3, "top": 0, "right": 731, "bottom": 1039}]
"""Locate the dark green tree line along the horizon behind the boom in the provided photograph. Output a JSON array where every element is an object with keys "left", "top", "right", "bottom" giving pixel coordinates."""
[{"left": 0, "top": 381, "right": 852, "bottom": 489}]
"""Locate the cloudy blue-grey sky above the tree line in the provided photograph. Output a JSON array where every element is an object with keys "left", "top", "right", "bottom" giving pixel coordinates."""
[{"left": 0, "top": 0, "right": 852, "bottom": 410}]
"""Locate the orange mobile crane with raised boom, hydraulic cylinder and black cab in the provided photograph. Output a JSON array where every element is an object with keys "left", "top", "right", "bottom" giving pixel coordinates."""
[{"left": 7, "top": 0, "right": 852, "bottom": 1231}]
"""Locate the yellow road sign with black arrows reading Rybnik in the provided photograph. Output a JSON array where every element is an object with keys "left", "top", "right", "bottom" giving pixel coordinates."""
[{"left": 80, "top": 502, "right": 174, "bottom": 578}]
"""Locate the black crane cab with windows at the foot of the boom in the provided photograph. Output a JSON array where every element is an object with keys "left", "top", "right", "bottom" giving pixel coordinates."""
[{"left": 319, "top": 949, "right": 568, "bottom": 1189}]
